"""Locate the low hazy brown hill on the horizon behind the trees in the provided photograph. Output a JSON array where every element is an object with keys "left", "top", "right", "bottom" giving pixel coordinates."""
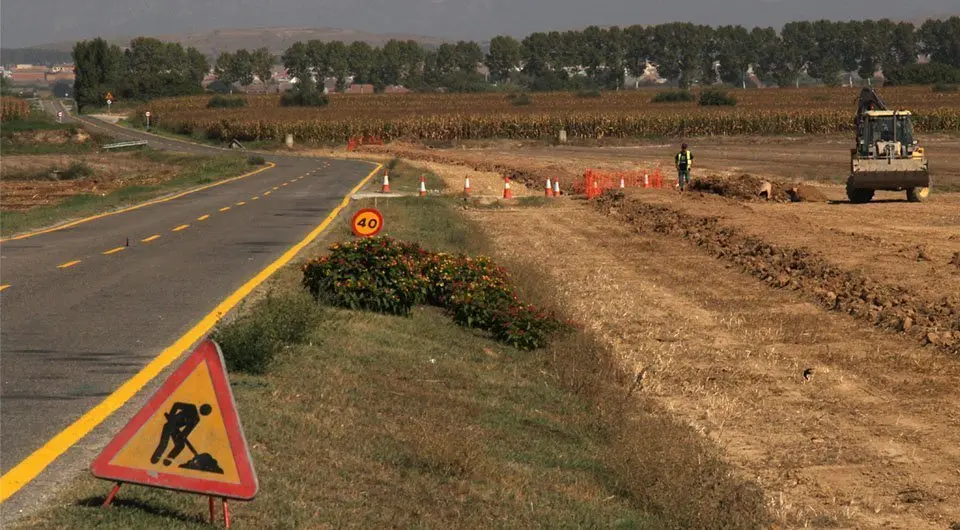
[{"left": 22, "top": 27, "right": 447, "bottom": 56}]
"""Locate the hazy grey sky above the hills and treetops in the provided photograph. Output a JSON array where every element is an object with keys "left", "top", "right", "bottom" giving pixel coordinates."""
[{"left": 0, "top": 0, "right": 960, "bottom": 47}]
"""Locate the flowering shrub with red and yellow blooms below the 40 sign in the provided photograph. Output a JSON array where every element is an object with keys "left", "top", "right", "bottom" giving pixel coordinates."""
[{"left": 303, "top": 237, "right": 567, "bottom": 350}]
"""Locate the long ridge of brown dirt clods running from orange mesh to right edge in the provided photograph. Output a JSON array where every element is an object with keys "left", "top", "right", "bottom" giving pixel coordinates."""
[{"left": 595, "top": 194, "right": 960, "bottom": 354}]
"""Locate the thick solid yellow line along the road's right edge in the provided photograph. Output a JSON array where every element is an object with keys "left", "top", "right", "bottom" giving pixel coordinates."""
[{"left": 0, "top": 159, "right": 383, "bottom": 503}]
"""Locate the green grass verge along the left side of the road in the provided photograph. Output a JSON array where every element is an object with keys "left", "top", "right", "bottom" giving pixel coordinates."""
[{"left": 0, "top": 150, "right": 256, "bottom": 237}]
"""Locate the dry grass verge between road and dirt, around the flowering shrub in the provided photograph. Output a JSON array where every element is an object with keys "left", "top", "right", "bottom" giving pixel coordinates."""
[{"left": 11, "top": 165, "right": 765, "bottom": 529}]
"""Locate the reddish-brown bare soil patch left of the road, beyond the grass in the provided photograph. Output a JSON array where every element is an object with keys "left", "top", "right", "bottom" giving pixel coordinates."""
[{"left": 0, "top": 153, "right": 179, "bottom": 211}]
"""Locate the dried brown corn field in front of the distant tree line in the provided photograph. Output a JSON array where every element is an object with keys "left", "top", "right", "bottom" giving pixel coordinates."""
[{"left": 141, "top": 87, "right": 960, "bottom": 144}]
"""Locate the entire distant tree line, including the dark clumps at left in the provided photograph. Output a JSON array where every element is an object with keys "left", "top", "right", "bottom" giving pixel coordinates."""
[{"left": 72, "top": 16, "right": 960, "bottom": 106}]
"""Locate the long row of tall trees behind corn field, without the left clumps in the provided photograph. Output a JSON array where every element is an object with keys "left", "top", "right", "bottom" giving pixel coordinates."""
[{"left": 281, "top": 17, "right": 960, "bottom": 91}]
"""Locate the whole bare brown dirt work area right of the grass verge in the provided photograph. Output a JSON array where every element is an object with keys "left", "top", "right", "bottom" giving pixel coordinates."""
[{"left": 354, "top": 137, "right": 960, "bottom": 529}]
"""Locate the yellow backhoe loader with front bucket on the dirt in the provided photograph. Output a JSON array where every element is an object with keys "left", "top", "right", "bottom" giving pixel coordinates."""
[{"left": 847, "top": 88, "right": 930, "bottom": 203}]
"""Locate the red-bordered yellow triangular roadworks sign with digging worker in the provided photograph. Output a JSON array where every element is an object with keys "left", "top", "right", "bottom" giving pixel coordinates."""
[{"left": 90, "top": 340, "right": 258, "bottom": 500}]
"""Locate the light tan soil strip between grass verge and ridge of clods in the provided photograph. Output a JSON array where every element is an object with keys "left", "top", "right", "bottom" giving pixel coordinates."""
[{"left": 469, "top": 204, "right": 960, "bottom": 528}]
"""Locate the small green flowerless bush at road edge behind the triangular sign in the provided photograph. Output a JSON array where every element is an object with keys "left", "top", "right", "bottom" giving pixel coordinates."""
[{"left": 211, "top": 293, "right": 318, "bottom": 374}]
